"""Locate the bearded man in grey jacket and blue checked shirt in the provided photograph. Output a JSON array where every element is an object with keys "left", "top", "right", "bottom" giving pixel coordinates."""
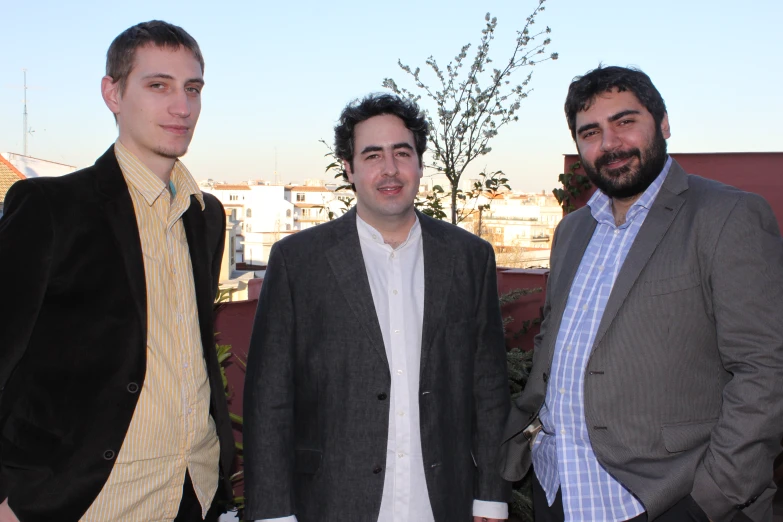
[{"left": 502, "top": 67, "right": 783, "bottom": 522}]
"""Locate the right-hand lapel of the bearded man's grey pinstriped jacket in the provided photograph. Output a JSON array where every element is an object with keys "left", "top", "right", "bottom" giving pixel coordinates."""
[{"left": 593, "top": 160, "right": 688, "bottom": 348}]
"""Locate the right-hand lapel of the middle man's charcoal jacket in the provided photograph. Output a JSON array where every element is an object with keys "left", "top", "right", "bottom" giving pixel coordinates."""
[{"left": 416, "top": 211, "right": 454, "bottom": 375}]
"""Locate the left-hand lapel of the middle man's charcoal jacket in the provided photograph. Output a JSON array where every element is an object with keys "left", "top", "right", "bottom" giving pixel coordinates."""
[{"left": 326, "top": 208, "right": 389, "bottom": 367}]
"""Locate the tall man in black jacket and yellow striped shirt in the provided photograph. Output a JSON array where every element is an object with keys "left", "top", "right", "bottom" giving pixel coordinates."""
[{"left": 0, "top": 21, "right": 233, "bottom": 522}]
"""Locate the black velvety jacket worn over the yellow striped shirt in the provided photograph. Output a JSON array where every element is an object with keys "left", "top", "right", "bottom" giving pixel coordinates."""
[{"left": 0, "top": 147, "right": 233, "bottom": 522}]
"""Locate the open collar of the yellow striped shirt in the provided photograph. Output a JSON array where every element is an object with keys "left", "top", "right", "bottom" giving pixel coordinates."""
[{"left": 114, "top": 139, "right": 205, "bottom": 210}]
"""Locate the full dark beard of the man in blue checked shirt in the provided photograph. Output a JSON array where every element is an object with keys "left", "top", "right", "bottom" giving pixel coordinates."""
[{"left": 580, "top": 125, "right": 666, "bottom": 199}]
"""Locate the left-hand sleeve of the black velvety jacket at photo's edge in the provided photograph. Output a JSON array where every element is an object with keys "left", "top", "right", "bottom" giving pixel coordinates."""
[{"left": 0, "top": 181, "right": 54, "bottom": 391}]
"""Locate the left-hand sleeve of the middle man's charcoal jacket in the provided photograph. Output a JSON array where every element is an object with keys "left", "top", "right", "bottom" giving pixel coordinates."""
[{"left": 244, "top": 243, "right": 295, "bottom": 520}]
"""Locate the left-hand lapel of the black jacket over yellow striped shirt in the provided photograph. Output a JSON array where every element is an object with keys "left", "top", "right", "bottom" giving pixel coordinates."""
[{"left": 95, "top": 145, "right": 147, "bottom": 338}]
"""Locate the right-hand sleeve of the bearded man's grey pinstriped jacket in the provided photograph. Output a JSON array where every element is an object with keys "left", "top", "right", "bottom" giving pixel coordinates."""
[{"left": 692, "top": 194, "right": 783, "bottom": 522}]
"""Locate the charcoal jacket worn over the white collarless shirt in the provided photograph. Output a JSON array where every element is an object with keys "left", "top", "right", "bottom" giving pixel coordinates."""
[{"left": 244, "top": 210, "right": 510, "bottom": 522}]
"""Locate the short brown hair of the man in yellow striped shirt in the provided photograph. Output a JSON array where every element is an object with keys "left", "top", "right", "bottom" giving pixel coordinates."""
[{"left": 106, "top": 20, "right": 204, "bottom": 95}]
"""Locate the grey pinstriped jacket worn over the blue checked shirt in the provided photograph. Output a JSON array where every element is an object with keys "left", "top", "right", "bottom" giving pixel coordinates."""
[{"left": 503, "top": 162, "right": 783, "bottom": 522}]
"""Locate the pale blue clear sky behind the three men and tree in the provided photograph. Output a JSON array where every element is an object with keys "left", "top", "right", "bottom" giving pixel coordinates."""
[{"left": 0, "top": 0, "right": 783, "bottom": 192}]
